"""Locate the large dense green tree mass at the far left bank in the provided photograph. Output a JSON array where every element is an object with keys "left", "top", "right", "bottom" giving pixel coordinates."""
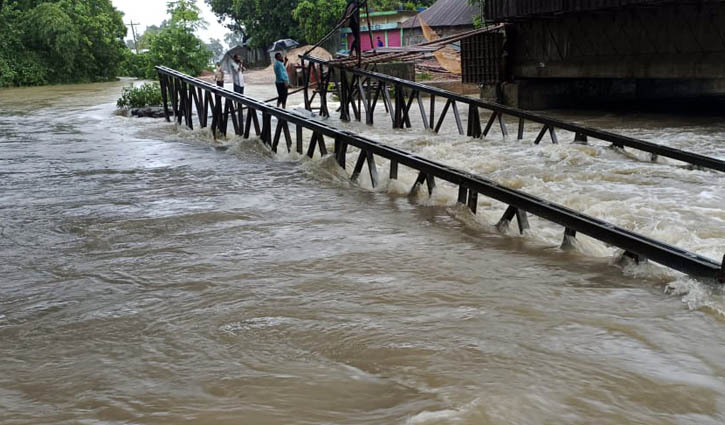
[{"left": 0, "top": 0, "right": 127, "bottom": 86}]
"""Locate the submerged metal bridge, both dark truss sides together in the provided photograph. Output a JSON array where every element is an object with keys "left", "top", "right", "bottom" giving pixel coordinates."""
[{"left": 156, "top": 66, "right": 725, "bottom": 283}]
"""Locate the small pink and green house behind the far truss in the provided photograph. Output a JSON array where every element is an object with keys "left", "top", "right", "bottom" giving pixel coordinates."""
[{"left": 341, "top": 10, "right": 418, "bottom": 52}]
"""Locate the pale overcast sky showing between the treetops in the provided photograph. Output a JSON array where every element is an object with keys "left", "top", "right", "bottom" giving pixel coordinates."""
[{"left": 112, "top": 0, "right": 229, "bottom": 44}]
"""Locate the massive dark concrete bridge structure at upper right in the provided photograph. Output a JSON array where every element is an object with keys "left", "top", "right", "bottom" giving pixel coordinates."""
[{"left": 485, "top": 0, "right": 725, "bottom": 109}]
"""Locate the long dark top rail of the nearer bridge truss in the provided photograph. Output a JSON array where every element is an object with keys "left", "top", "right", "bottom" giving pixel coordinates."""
[{"left": 156, "top": 67, "right": 723, "bottom": 280}]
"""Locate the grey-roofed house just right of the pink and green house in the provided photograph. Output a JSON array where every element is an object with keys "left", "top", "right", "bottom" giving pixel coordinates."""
[{"left": 402, "top": 0, "right": 479, "bottom": 46}]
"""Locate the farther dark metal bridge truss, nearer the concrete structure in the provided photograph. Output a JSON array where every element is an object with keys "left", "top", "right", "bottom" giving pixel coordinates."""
[{"left": 302, "top": 56, "right": 725, "bottom": 172}]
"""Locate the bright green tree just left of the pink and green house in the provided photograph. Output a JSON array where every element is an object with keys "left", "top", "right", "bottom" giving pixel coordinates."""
[{"left": 292, "top": 0, "right": 347, "bottom": 42}]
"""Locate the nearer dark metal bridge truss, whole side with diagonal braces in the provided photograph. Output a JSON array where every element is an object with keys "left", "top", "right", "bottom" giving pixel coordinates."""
[{"left": 156, "top": 66, "right": 725, "bottom": 282}]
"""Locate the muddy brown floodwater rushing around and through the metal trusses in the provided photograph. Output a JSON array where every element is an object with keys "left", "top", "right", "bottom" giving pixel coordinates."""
[{"left": 0, "top": 77, "right": 725, "bottom": 425}]
